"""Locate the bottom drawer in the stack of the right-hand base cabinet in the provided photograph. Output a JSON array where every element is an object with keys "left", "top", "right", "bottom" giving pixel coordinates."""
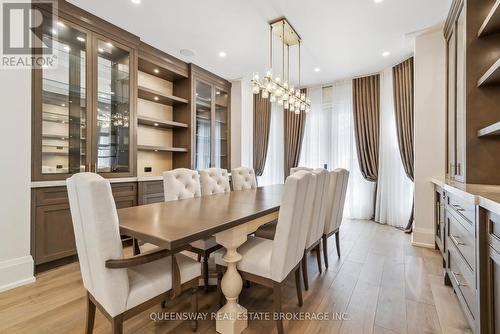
[{"left": 448, "top": 245, "right": 476, "bottom": 320}]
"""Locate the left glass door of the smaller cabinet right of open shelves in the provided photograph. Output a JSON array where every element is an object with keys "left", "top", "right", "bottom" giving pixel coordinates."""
[{"left": 195, "top": 81, "right": 212, "bottom": 170}]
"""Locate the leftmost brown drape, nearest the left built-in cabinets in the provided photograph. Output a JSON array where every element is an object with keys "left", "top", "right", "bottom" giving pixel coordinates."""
[{"left": 253, "top": 94, "right": 271, "bottom": 176}]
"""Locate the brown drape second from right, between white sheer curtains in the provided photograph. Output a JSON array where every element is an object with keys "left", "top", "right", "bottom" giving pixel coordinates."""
[{"left": 352, "top": 74, "right": 380, "bottom": 182}]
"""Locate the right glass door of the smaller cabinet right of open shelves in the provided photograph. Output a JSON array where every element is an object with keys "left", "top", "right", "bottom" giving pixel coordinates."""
[{"left": 214, "top": 88, "right": 229, "bottom": 169}]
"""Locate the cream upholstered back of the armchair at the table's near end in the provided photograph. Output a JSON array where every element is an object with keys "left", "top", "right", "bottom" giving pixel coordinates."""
[{"left": 66, "top": 173, "right": 129, "bottom": 316}]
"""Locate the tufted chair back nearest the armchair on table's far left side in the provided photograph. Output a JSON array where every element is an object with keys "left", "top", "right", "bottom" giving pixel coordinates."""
[{"left": 163, "top": 168, "right": 201, "bottom": 202}]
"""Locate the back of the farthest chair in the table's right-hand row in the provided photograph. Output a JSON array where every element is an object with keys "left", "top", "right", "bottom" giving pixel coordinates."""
[{"left": 324, "top": 168, "right": 349, "bottom": 234}]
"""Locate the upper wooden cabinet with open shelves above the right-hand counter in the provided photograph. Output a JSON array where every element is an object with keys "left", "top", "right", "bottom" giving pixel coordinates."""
[{"left": 444, "top": 0, "right": 500, "bottom": 185}]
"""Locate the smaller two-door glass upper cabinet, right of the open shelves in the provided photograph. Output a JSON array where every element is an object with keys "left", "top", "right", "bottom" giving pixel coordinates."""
[{"left": 192, "top": 66, "right": 231, "bottom": 169}]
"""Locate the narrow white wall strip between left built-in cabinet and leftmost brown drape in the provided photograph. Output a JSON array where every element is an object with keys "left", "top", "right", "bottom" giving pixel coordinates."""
[{"left": 231, "top": 78, "right": 253, "bottom": 168}]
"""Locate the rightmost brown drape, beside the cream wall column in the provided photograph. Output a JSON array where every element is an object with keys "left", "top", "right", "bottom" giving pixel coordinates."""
[{"left": 392, "top": 57, "right": 414, "bottom": 232}]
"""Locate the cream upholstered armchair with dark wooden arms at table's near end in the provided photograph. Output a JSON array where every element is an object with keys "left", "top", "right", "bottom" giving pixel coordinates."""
[{"left": 66, "top": 173, "right": 201, "bottom": 333}]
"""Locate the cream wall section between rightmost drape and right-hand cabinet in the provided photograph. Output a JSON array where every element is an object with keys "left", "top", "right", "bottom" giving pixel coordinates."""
[{"left": 412, "top": 27, "right": 446, "bottom": 247}]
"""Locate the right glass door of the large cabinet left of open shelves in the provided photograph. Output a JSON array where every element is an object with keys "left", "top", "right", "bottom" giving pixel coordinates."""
[{"left": 94, "top": 39, "right": 131, "bottom": 173}]
